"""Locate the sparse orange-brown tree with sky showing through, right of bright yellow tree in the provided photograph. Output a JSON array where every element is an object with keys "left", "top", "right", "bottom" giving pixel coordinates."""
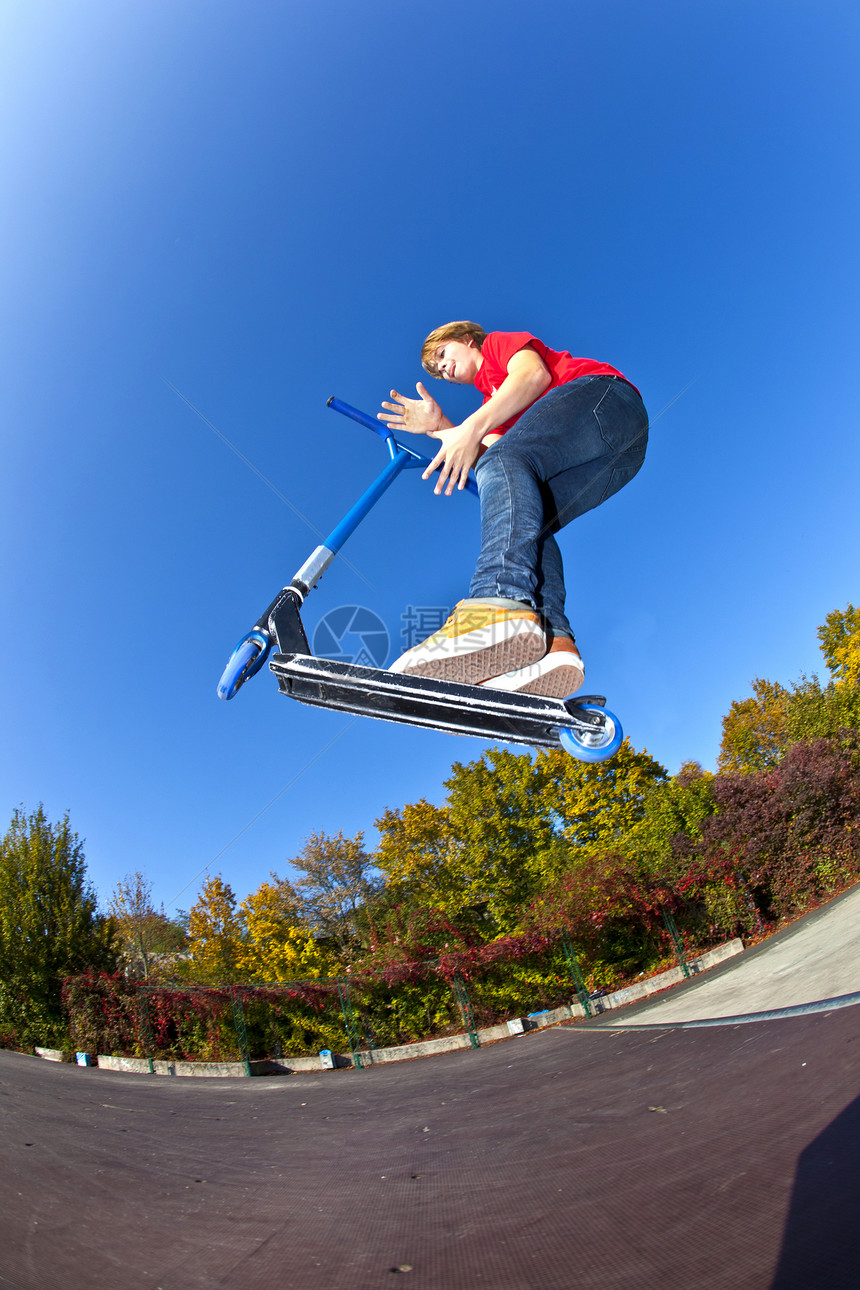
[{"left": 288, "top": 833, "right": 379, "bottom": 953}]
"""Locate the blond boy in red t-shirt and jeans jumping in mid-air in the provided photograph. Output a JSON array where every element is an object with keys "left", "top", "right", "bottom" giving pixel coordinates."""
[{"left": 378, "top": 321, "right": 649, "bottom": 698}]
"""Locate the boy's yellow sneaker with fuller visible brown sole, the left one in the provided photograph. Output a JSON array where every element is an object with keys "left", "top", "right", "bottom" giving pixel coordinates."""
[{"left": 388, "top": 599, "right": 547, "bottom": 685}]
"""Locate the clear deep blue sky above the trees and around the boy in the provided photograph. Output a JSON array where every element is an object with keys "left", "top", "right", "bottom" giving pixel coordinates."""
[{"left": 0, "top": 0, "right": 860, "bottom": 909}]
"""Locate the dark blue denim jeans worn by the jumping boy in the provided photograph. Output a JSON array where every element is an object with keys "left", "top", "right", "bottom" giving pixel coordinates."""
[{"left": 469, "top": 377, "right": 649, "bottom": 637}]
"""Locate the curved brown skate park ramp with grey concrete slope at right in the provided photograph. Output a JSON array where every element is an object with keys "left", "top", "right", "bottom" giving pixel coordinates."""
[{"left": 0, "top": 894, "right": 860, "bottom": 1290}]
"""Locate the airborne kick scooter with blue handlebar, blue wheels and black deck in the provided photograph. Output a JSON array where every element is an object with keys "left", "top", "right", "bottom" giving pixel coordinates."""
[{"left": 218, "top": 397, "right": 624, "bottom": 762}]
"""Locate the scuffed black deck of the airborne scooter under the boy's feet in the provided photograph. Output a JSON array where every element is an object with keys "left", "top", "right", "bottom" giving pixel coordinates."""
[{"left": 268, "top": 654, "right": 606, "bottom": 748}]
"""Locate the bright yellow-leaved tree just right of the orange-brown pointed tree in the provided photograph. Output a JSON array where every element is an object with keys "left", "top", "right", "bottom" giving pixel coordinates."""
[{"left": 239, "top": 873, "right": 334, "bottom": 982}]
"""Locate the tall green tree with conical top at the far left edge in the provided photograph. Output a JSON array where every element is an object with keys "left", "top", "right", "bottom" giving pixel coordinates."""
[{"left": 0, "top": 805, "right": 116, "bottom": 1046}]
